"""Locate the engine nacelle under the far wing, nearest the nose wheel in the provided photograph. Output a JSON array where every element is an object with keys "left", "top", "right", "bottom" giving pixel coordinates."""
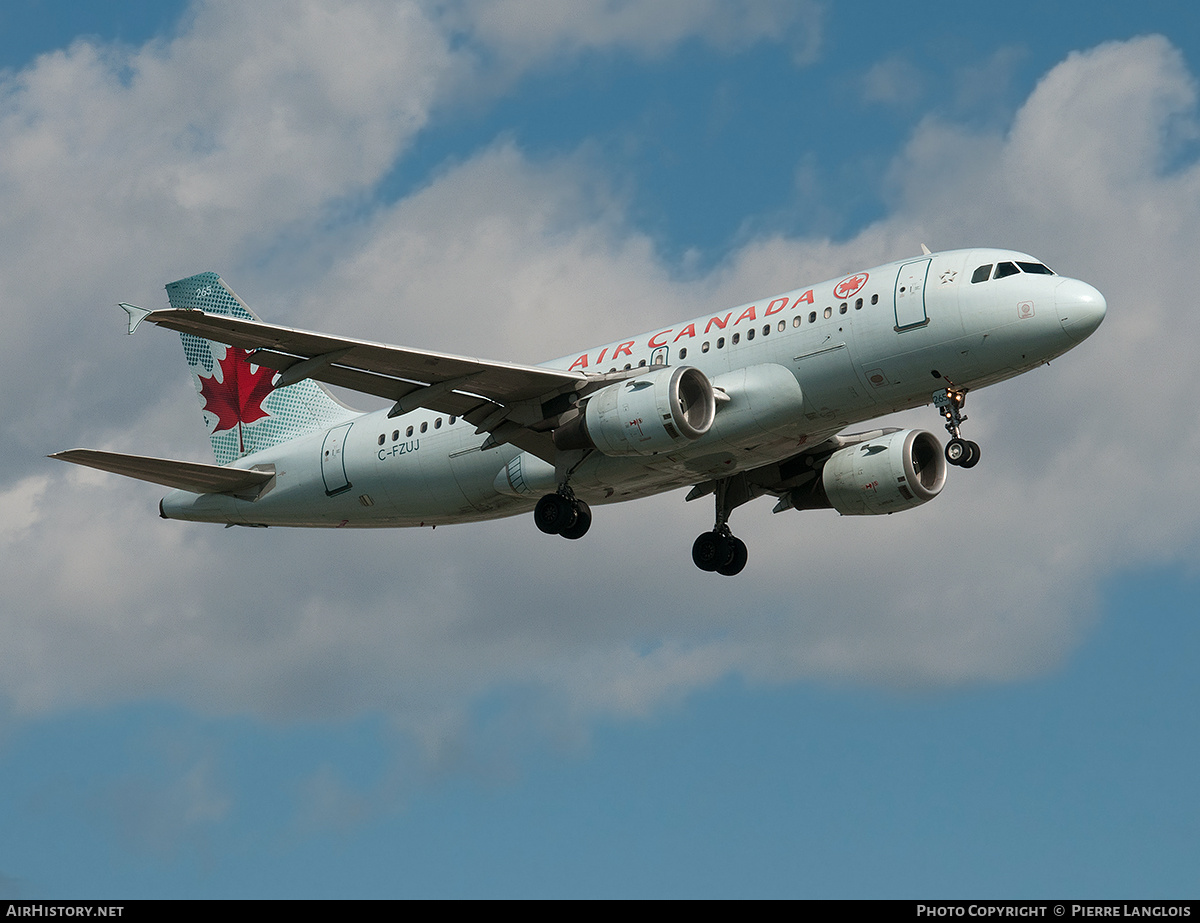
[{"left": 821, "top": 430, "right": 946, "bottom": 516}]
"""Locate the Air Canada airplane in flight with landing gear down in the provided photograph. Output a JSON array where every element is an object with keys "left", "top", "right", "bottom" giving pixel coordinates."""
[{"left": 49, "top": 245, "right": 1106, "bottom": 576}]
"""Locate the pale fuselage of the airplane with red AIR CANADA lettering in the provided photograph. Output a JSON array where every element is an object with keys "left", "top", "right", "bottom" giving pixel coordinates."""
[{"left": 161, "top": 248, "right": 1105, "bottom": 527}]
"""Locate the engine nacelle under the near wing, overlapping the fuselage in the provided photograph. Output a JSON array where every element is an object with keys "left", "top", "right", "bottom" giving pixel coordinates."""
[{"left": 554, "top": 365, "right": 716, "bottom": 456}]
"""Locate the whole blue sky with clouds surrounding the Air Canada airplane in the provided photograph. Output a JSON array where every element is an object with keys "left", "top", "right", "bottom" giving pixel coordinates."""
[{"left": 0, "top": 0, "right": 1200, "bottom": 898}]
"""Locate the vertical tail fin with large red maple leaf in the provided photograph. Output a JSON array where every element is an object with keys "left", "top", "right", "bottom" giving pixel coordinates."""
[{"left": 167, "top": 272, "right": 355, "bottom": 465}]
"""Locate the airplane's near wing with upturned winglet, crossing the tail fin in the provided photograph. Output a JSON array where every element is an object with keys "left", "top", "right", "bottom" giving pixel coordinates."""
[{"left": 121, "top": 304, "right": 644, "bottom": 463}]
